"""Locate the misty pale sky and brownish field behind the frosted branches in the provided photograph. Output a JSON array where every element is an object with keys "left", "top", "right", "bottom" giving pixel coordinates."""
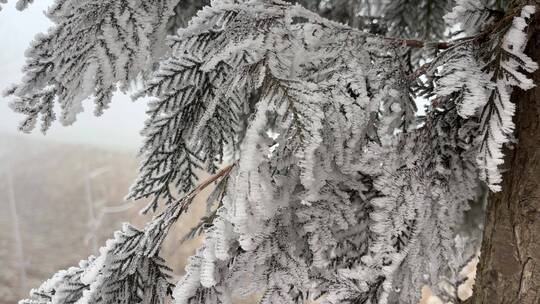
[{"left": 0, "top": 0, "right": 163, "bottom": 304}]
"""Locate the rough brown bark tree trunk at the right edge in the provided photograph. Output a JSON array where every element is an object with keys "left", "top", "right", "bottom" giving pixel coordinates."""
[{"left": 468, "top": 14, "right": 540, "bottom": 304}]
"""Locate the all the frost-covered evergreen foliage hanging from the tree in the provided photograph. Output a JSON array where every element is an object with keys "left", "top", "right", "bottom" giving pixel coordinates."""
[{"left": 3, "top": 0, "right": 537, "bottom": 304}]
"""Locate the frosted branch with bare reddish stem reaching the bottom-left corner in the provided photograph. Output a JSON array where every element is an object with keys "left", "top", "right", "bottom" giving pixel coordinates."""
[{"left": 21, "top": 165, "right": 233, "bottom": 304}]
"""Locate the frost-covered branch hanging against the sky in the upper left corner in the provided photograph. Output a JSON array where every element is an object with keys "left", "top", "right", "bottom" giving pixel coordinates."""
[{"left": 5, "top": 0, "right": 178, "bottom": 132}]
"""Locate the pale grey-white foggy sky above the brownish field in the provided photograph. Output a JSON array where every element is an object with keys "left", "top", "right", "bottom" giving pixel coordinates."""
[{"left": 0, "top": 0, "right": 146, "bottom": 152}]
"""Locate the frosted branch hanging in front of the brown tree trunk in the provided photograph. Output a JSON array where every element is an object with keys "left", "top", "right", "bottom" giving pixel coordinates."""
[{"left": 424, "top": 1, "right": 538, "bottom": 191}]
